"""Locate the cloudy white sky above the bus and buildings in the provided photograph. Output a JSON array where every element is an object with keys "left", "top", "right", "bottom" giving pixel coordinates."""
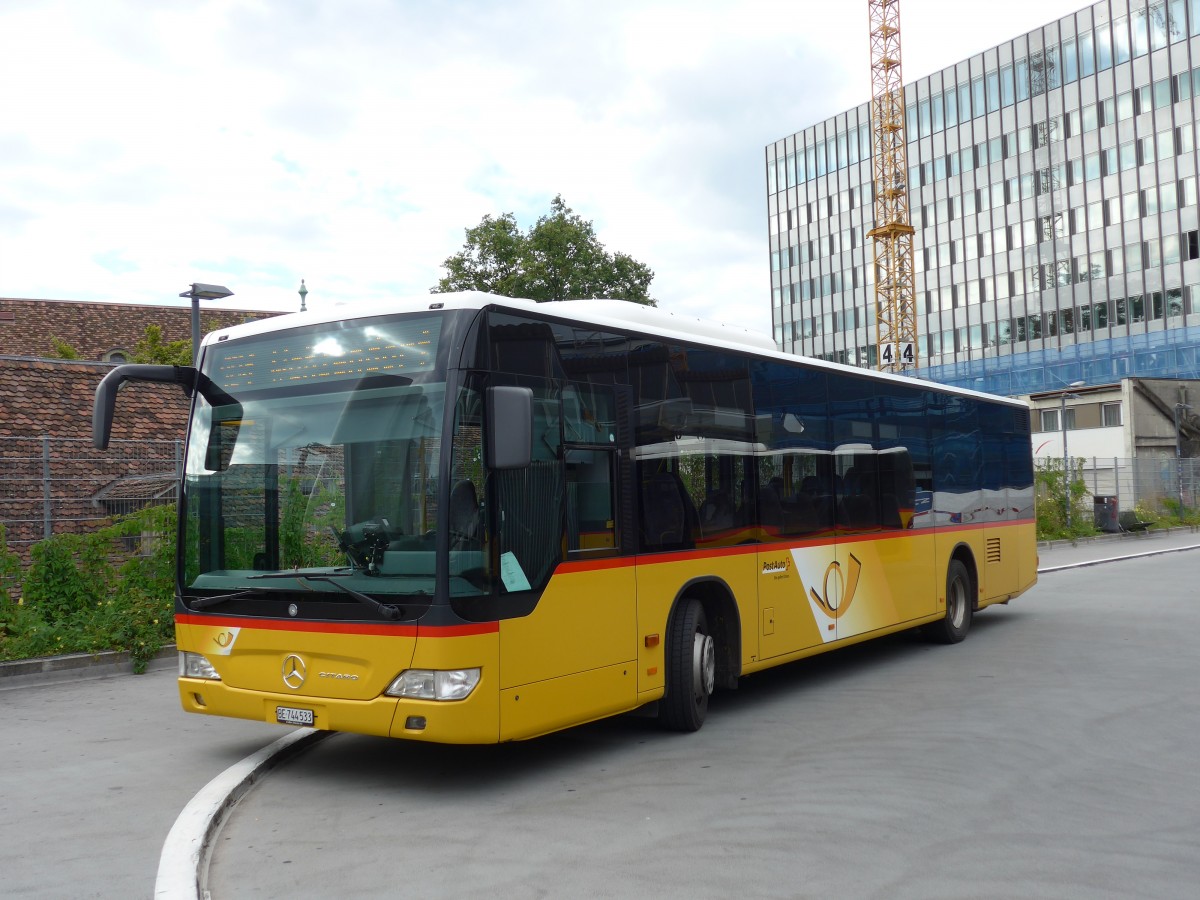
[{"left": 0, "top": 0, "right": 1084, "bottom": 332}]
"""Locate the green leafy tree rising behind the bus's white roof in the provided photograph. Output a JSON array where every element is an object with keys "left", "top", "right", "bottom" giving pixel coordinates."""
[{"left": 432, "top": 194, "right": 655, "bottom": 306}]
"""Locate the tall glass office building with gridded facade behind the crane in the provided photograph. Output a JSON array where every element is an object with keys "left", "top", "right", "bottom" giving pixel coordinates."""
[{"left": 766, "top": 0, "right": 1200, "bottom": 394}]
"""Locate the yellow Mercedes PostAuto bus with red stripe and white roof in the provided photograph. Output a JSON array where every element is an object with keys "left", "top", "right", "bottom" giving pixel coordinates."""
[{"left": 94, "top": 293, "right": 1037, "bottom": 743}]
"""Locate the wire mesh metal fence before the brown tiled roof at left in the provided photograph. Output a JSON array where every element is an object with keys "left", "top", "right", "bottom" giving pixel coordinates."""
[{"left": 0, "top": 437, "right": 184, "bottom": 559}]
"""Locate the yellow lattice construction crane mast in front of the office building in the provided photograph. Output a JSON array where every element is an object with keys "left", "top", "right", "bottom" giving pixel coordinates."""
[{"left": 868, "top": 0, "right": 918, "bottom": 372}]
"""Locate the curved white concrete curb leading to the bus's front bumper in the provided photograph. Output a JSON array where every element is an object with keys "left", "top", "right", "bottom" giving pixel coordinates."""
[{"left": 154, "top": 728, "right": 336, "bottom": 900}]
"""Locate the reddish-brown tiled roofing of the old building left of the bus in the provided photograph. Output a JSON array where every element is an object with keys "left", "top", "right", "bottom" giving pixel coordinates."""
[{"left": 0, "top": 298, "right": 285, "bottom": 556}]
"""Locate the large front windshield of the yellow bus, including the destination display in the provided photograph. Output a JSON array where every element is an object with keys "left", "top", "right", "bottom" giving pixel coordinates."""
[{"left": 182, "top": 318, "right": 445, "bottom": 600}]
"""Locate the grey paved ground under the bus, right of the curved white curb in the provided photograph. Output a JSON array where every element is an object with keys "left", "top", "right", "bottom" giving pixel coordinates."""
[{"left": 209, "top": 545, "right": 1200, "bottom": 900}]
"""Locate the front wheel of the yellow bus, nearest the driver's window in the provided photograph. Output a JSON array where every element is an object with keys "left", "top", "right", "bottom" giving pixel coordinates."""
[{"left": 659, "top": 598, "right": 716, "bottom": 731}]
